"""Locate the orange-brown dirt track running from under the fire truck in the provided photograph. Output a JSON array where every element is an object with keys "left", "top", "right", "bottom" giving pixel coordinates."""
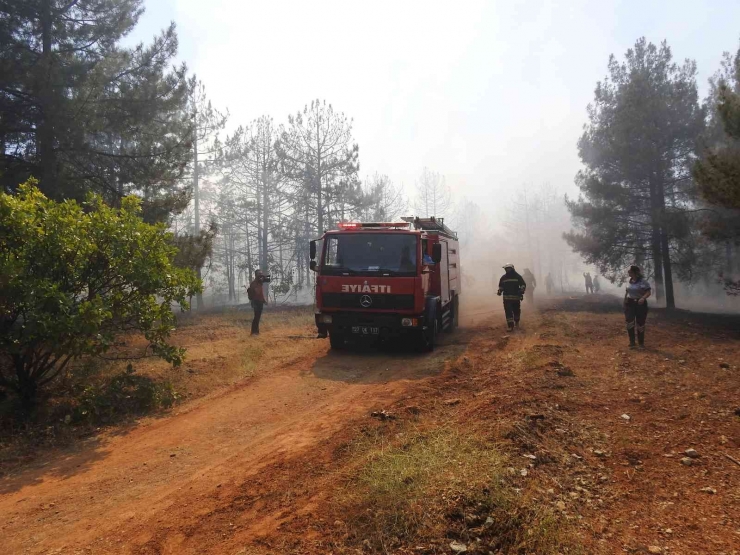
[{"left": 0, "top": 312, "right": 466, "bottom": 554}]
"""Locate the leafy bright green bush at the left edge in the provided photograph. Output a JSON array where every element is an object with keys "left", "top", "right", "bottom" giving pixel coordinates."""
[{"left": 0, "top": 181, "right": 201, "bottom": 410}]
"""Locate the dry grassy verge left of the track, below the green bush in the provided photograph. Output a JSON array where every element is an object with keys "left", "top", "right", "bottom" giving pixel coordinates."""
[{"left": 0, "top": 307, "right": 313, "bottom": 476}]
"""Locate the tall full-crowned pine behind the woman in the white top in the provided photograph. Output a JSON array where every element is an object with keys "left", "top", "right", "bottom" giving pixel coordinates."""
[{"left": 565, "top": 38, "right": 704, "bottom": 308}]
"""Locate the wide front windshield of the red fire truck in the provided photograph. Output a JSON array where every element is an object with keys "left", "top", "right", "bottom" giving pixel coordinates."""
[{"left": 321, "top": 232, "right": 418, "bottom": 276}]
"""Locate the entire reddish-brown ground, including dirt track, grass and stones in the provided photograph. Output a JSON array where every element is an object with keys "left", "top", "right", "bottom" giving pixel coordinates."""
[{"left": 0, "top": 296, "right": 740, "bottom": 555}]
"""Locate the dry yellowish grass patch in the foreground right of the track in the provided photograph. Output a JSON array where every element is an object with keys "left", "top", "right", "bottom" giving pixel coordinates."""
[{"left": 337, "top": 426, "right": 575, "bottom": 555}]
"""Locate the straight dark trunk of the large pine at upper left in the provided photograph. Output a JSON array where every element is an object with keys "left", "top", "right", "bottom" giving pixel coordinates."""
[{"left": 37, "top": 0, "right": 55, "bottom": 197}]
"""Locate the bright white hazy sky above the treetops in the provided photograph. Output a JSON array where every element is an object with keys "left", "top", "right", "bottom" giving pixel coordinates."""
[{"left": 134, "top": 0, "right": 740, "bottom": 208}]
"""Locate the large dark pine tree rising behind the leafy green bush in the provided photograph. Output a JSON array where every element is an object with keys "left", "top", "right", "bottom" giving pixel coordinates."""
[{"left": 0, "top": 0, "right": 192, "bottom": 219}]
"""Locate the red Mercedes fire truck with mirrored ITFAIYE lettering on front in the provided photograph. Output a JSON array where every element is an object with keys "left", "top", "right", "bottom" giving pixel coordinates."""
[{"left": 310, "top": 218, "right": 461, "bottom": 351}]
